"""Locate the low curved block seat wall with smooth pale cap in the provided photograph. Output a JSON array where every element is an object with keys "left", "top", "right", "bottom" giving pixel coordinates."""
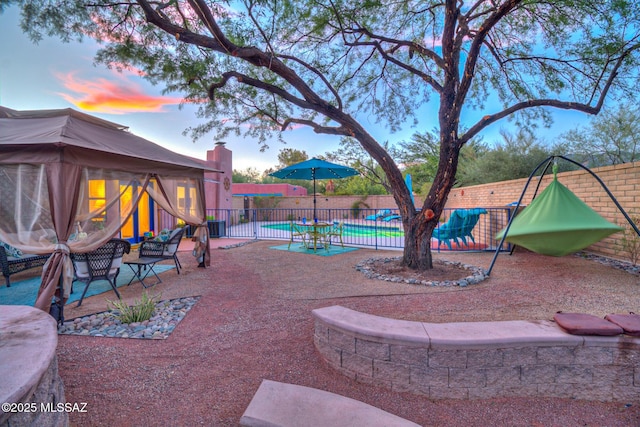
[{"left": 313, "top": 306, "right": 640, "bottom": 402}]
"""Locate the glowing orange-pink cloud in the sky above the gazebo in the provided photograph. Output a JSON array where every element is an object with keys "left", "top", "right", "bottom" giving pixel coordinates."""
[{"left": 57, "top": 73, "right": 182, "bottom": 114}]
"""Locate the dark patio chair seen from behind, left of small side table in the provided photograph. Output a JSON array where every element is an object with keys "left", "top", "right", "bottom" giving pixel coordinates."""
[{"left": 71, "top": 239, "right": 131, "bottom": 307}]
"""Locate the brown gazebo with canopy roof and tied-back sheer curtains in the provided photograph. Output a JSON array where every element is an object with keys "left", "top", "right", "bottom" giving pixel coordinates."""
[{"left": 0, "top": 106, "right": 220, "bottom": 311}]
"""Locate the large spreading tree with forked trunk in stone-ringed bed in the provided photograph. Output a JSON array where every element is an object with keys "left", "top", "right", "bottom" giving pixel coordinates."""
[{"left": 6, "top": 0, "right": 640, "bottom": 269}]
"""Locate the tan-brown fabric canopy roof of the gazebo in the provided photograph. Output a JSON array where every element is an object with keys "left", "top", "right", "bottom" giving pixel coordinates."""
[{"left": 0, "top": 106, "right": 221, "bottom": 176}]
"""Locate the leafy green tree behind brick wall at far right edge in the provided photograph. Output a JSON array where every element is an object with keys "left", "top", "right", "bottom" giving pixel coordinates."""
[{"left": 562, "top": 103, "right": 640, "bottom": 167}]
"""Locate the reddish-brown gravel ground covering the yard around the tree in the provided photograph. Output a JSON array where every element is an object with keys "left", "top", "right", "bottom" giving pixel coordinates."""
[{"left": 58, "top": 242, "right": 640, "bottom": 426}]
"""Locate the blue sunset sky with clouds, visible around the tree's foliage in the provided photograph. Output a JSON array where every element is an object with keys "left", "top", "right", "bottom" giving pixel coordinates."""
[{"left": 0, "top": 6, "right": 588, "bottom": 172}]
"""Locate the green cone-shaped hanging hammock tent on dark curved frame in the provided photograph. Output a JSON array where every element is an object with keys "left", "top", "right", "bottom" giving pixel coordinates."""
[{"left": 496, "top": 171, "right": 623, "bottom": 256}]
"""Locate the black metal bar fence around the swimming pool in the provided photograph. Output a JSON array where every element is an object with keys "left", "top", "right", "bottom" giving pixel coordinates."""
[{"left": 158, "top": 207, "right": 514, "bottom": 251}]
